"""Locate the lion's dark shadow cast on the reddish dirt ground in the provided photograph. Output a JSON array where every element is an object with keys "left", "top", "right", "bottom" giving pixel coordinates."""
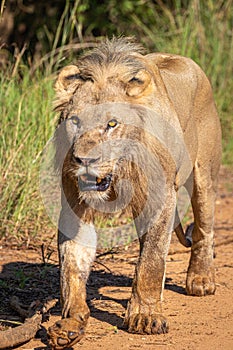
[{"left": 0, "top": 262, "right": 185, "bottom": 349}]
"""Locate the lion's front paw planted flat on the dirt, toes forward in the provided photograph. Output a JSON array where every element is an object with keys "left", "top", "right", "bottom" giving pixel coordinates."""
[{"left": 124, "top": 314, "right": 168, "bottom": 334}]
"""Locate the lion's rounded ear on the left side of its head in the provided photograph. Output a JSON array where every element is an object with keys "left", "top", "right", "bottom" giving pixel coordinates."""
[{"left": 54, "top": 65, "right": 80, "bottom": 93}]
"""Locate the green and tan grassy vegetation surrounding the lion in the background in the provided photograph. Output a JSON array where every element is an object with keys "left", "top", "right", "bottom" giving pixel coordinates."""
[{"left": 0, "top": 0, "right": 233, "bottom": 239}]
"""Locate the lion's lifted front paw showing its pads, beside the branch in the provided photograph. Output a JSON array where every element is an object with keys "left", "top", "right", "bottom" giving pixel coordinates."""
[{"left": 48, "top": 318, "right": 85, "bottom": 350}]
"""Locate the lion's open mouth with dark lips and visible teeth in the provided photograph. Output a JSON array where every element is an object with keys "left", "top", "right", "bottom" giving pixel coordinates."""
[{"left": 78, "top": 173, "right": 112, "bottom": 192}]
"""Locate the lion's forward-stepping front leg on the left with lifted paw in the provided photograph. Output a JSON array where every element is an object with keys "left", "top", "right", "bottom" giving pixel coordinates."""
[{"left": 48, "top": 215, "right": 96, "bottom": 349}]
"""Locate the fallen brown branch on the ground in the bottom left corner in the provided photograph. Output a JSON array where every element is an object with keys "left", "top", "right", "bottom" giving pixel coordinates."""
[{"left": 0, "top": 297, "right": 57, "bottom": 349}]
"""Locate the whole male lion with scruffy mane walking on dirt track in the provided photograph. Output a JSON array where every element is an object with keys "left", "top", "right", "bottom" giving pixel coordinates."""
[{"left": 49, "top": 38, "right": 221, "bottom": 349}]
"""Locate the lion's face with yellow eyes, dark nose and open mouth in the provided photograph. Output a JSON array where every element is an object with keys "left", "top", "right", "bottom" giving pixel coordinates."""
[{"left": 59, "top": 103, "right": 148, "bottom": 200}]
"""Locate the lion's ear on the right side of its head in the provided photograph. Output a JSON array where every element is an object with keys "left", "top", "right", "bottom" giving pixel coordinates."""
[{"left": 126, "top": 70, "right": 151, "bottom": 97}]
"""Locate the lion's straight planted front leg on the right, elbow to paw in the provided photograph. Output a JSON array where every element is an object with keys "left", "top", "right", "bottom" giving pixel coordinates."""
[{"left": 124, "top": 196, "right": 175, "bottom": 334}]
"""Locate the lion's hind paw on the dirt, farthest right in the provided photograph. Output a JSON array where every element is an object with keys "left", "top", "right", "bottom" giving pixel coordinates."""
[{"left": 186, "top": 273, "right": 216, "bottom": 296}]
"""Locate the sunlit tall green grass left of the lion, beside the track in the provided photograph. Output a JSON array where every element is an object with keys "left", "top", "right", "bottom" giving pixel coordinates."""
[{"left": 0, "top": 71, "right": 53, "bottom": 236}]
